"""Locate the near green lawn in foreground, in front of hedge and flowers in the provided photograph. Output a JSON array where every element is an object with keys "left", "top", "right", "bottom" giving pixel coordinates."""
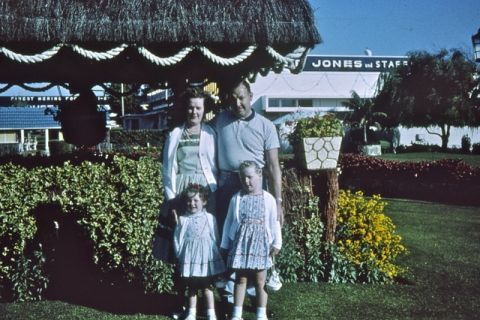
[{"left": 0, "top": 200, "right": 480, "bottom": 320}]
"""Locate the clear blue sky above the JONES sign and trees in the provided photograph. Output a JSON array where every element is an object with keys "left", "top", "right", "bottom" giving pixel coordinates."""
[{"left": 309, "top": 0, "right": 480, "bottom": 56}]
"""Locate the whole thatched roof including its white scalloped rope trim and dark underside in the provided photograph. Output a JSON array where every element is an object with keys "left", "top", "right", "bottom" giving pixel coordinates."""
[{"left": 0, "top": 0, "right": 321, "bottom": 83}]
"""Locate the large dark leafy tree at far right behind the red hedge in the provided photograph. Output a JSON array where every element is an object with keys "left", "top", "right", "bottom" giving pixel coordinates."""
[{"left": 375, "top": 49, "right": 480, "bottom": 149}]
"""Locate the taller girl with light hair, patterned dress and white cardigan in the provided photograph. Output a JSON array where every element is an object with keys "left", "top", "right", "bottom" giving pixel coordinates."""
[{"left": 221, "top": 161, "right": 282, "bottom": 320}]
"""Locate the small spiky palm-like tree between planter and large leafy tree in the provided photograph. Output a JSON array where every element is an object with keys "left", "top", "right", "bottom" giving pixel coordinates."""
[{"left": 342, "top": 91, "right": 387, "bottom": 144}]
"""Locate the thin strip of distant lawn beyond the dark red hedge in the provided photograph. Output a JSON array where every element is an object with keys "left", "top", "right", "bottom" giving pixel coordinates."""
[{"left": 379, "top": 152, "right": 480, "bottom": 167}]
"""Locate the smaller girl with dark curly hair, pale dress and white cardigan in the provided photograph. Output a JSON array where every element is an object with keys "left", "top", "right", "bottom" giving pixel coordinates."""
[{"left": 173, "top": 184, "right": 225, "bottom": 320}]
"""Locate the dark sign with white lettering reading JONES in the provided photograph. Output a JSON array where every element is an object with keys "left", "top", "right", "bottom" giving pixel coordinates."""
[{"left": 303, "top": 56, "right": 408, "bottom": 72}]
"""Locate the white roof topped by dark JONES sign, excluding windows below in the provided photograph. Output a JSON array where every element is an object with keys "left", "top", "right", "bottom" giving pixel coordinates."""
[{"left": 252, "top": 55, "right": 408, "bottom": 99}]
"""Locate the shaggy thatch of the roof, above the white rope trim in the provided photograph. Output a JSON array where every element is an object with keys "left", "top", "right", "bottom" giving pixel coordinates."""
[{"left": 0, "top": 0, "right": 320, "bottom": 46}]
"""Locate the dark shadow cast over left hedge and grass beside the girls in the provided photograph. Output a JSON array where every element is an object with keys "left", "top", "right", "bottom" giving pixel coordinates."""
[{"left": 33, "top": 204, "right": 183, "bottom": 315}]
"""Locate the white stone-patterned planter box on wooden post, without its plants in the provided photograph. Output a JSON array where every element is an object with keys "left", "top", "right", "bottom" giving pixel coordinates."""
[{"left": 303, "top": 136, "right": 342, "bottom": 170}]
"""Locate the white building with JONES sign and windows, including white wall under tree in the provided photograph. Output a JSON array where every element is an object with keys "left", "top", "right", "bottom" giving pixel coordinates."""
[{"left": 251, "top": 55, "right": 480, "bottom": 147}]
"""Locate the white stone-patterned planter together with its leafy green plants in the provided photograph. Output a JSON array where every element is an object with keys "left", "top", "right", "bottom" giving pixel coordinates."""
[{"left": 288, "top": 114, "right": 343, "bottom": 170}]
